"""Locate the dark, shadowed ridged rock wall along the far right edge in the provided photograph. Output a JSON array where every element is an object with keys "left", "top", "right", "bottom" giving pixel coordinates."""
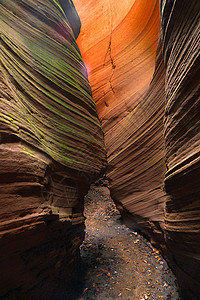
[{"left": 161, "top": 0, "right": 200, "bottom": 299}]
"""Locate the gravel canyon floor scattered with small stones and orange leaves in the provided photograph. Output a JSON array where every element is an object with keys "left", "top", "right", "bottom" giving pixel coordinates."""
[{"left": 76, "top": 186, "right": 180, "bottom": 300}]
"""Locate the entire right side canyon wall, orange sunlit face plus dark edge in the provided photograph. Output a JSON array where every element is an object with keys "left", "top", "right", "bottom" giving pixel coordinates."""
[{"left": 74, "top": 0, "right": 200, "bottom": 299}]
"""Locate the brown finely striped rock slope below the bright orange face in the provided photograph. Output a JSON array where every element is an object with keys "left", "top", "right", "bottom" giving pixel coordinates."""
[{"left": 108, "top": 41, "right": 166, "bottom": 246}]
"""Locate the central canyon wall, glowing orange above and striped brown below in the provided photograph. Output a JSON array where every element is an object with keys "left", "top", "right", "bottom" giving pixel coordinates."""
[{"left": 74, "top": 0, "right": 165, "bottom": 247}]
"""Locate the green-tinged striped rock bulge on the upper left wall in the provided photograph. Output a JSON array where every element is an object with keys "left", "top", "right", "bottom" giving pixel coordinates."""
[{"left": 0, "top": 0, "right": 105, "bottom": 172}]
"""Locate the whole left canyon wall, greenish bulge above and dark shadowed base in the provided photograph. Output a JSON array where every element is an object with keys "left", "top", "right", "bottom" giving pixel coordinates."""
[{"left": 0, "top": 0, "right": 106, "bottom": 299}]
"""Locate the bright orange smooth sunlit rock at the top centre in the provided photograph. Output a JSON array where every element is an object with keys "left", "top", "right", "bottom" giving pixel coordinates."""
[{"left": 74, "top": 0, "right": 159, "bottom": 129}]
